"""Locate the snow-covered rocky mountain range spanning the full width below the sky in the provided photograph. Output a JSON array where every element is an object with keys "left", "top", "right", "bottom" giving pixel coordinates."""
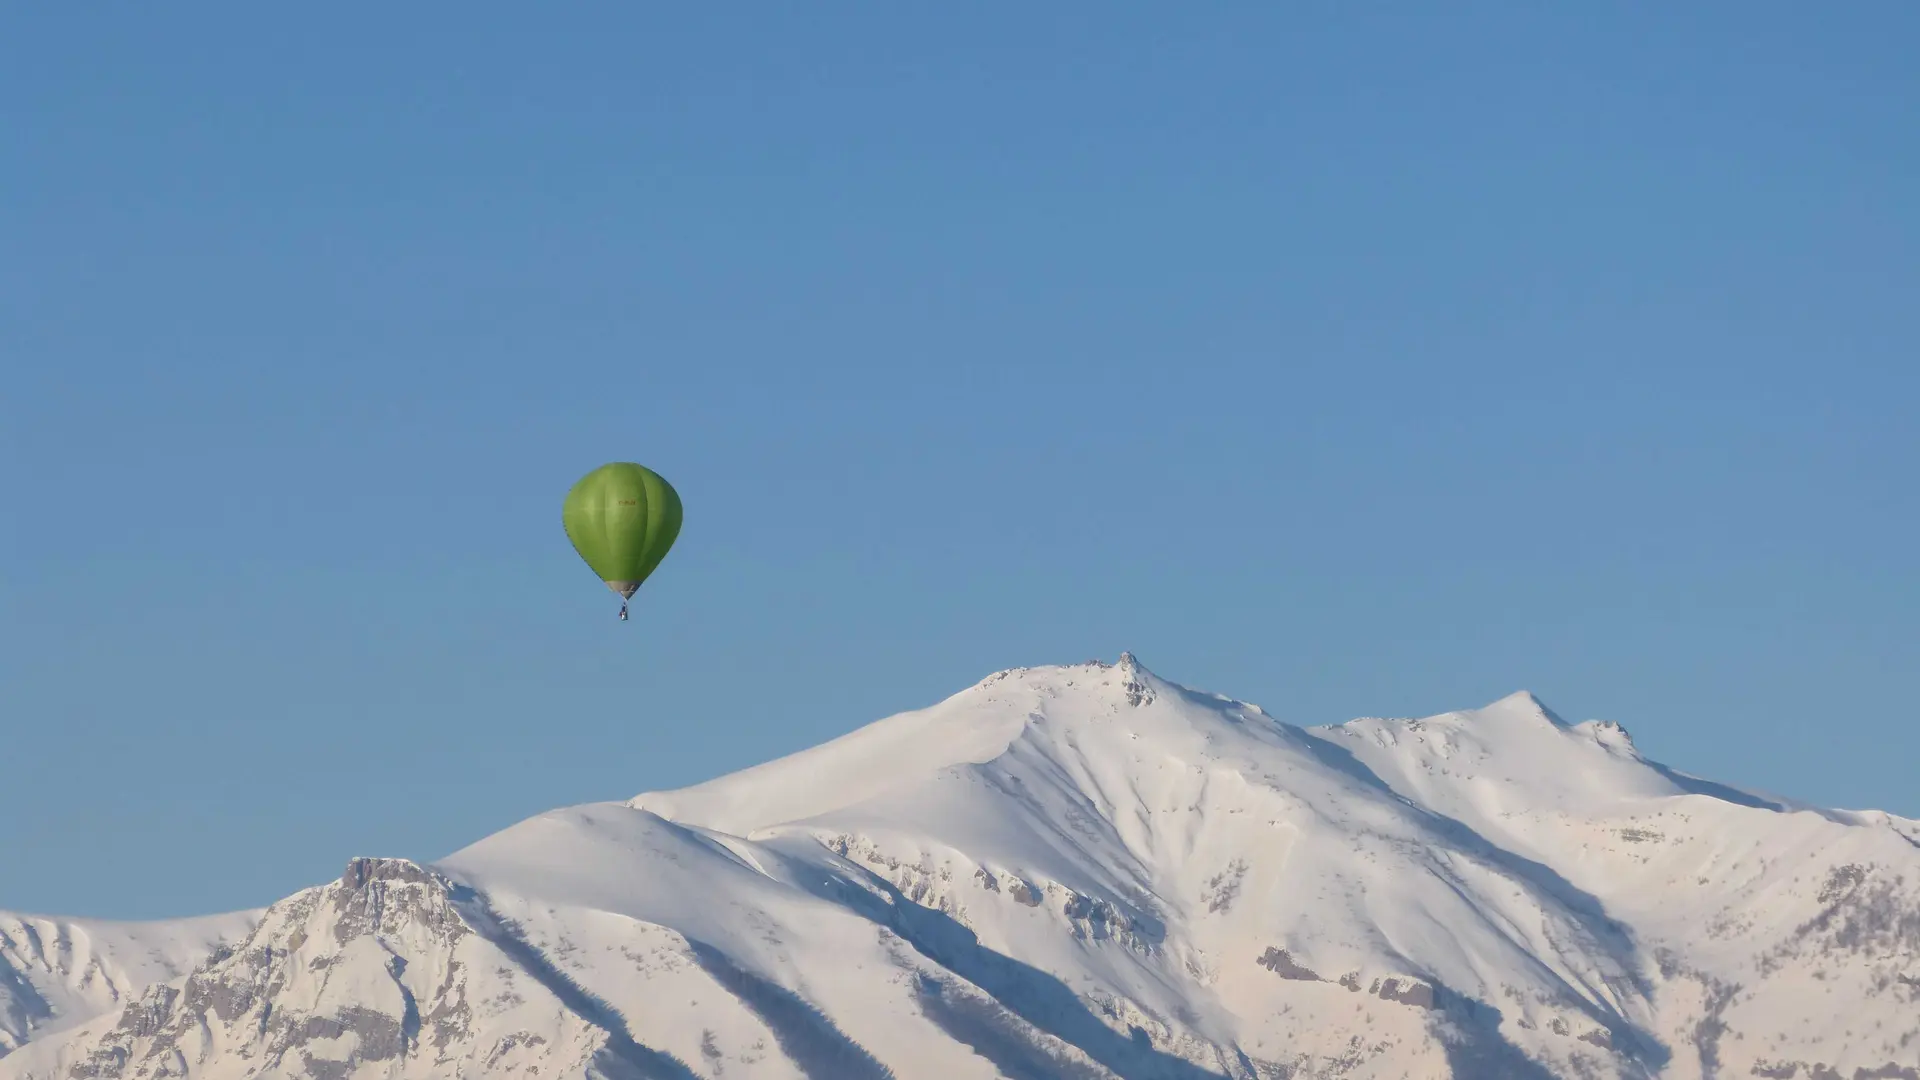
[{"left": 0, "top": 657, "right": 1920, "bottom": 1080}]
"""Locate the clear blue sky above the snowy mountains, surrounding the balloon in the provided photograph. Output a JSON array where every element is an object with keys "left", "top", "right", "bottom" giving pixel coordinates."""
[{"left": 0, "top": 2, "right": 1920, "bottom": 917}]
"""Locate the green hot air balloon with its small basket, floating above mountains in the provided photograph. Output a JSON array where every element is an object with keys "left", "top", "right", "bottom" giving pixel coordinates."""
[{"left": 561, "top": 461, "right": 680, "bottom": 619}]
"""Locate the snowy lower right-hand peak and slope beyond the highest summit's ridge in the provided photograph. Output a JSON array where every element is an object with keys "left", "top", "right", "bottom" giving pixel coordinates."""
[{"left": 1311, "top": 696, "right": 1920, "bottom": 1076}]
